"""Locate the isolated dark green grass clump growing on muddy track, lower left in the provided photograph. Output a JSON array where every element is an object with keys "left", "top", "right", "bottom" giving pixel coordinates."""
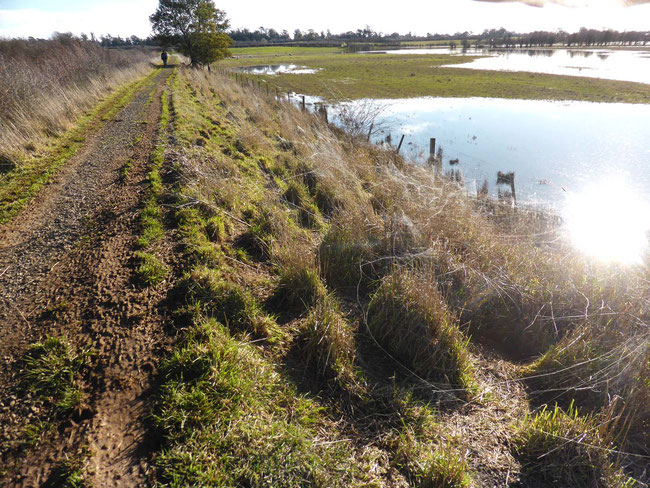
[{"left": 22, "top": 336, "right": 91, "bottom": 414}]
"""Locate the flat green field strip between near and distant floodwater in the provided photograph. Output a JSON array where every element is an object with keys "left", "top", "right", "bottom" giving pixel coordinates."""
[{"left": 220, "top": 48, "right": 650, "bottom": 103}]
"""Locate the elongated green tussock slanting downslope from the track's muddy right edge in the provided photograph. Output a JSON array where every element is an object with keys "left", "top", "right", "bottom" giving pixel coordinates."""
[{"left": 182, "top": 267, "right": 277, "bottom": 337}]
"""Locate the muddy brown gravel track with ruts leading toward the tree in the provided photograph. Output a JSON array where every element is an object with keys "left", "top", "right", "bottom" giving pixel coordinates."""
[{"left": 0, "top": 70, "right": 172, "bottom": 487}]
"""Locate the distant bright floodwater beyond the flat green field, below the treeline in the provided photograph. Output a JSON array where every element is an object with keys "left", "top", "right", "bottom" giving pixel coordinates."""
[{"left": 360, "top": 47, "right": 650, "bottom": 83}]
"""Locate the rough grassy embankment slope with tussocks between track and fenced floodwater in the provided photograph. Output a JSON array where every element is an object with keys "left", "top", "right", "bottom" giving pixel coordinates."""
[{"left": 152, "top": 66, "right": 650, "bottom": 487}]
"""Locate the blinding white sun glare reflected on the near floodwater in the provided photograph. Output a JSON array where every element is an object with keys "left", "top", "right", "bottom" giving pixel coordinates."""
[{"left": 564, "top": 176, "right": 650, "bottom": 264}]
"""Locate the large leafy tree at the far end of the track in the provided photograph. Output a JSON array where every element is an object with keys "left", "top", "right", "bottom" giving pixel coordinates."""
[{"left": 149, "top": 0, "right": 232, "bottom": 66}]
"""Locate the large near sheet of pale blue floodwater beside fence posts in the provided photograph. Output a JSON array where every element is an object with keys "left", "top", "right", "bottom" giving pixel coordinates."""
[{"left": 330, "top": 97, "right": 650, "bottom": 262}]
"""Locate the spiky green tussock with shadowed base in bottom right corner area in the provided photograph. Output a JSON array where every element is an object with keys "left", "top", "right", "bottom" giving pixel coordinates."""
[{"left": 514, "top": 406, "right": 634, "bottom": 487}]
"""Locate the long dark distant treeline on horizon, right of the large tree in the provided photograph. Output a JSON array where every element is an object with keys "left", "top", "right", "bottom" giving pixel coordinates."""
[{"left": 228, "top": 26, "right": 650, "bottom": 47}]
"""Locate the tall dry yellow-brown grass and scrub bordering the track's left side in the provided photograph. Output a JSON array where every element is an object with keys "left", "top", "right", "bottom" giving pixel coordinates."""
[{"left": 0, "top": 35, "right": 153, "bottom": 158}]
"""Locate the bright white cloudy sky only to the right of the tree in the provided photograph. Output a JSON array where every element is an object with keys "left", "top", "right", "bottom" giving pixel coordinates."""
[{"left": 217, "top": 0, "right": 650, "bottom": 34}]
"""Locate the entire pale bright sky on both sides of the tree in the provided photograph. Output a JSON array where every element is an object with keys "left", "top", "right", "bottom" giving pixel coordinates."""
[{"left": 0, "top": 0, "right": 650, "bottom": 37}]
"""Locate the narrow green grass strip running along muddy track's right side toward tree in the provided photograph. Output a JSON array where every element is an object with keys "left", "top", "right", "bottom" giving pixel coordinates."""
[{"left": 135, "top": 69, "right": 176, "bottom": 286}]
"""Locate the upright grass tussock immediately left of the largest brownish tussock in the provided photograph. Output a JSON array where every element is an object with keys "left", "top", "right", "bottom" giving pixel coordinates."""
[{"left": 298, "top": 294, "right": 356, "bottom": 387}]
